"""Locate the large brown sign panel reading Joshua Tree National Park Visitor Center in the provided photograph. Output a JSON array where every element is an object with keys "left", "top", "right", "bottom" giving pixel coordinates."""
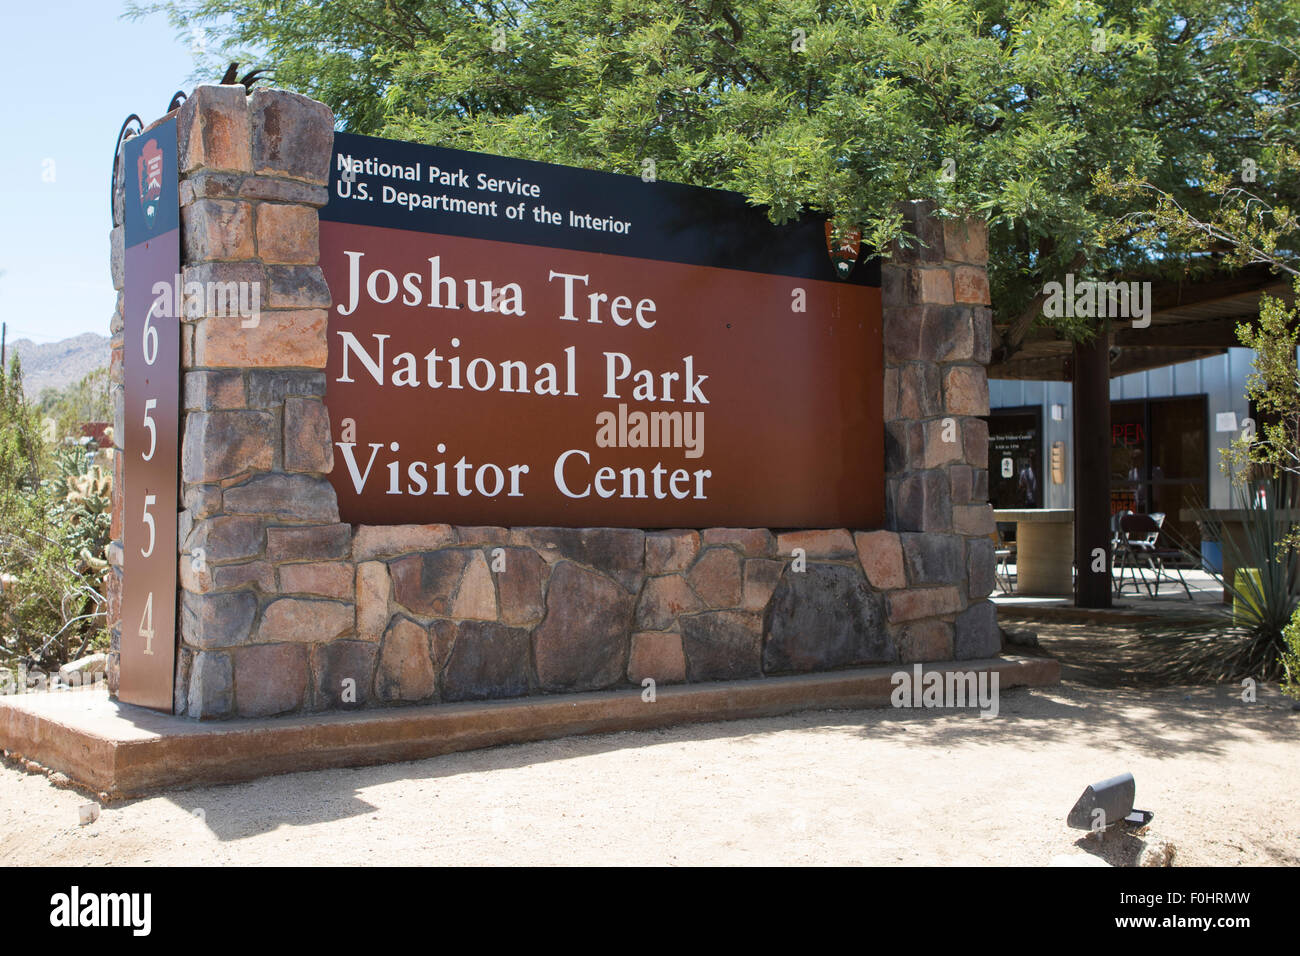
[{"left": 321, "top": 135, "right": 884, "bottom": 528}]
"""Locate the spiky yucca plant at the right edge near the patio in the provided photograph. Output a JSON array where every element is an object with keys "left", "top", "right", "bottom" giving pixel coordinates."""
[{"left": 1130, "top": 477, "right": 1300, "bottom": 683}]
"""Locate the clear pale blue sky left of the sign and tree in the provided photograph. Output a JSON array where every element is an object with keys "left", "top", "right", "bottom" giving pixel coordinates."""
[{"left": 0, "top": 0, "right": 205, "bottom": 342}]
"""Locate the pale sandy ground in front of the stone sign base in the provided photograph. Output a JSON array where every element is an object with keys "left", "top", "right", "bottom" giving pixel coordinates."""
[{"left": 0, "top": 627, "right": 1300, "bottom": 865}]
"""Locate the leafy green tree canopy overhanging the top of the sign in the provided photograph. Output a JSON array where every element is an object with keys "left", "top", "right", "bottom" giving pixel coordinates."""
[{"left": 135, "top": 0, "right": 1300, "bottom": 358}]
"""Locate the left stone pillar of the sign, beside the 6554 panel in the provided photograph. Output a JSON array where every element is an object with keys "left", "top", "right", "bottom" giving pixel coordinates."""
[{"left": 176, "top": 86, "right": 355, "bottom": 718}]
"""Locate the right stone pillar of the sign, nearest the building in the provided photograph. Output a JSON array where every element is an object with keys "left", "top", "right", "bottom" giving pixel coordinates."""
[{"left": 868, "top": 202, "right": 1000, "bottom": 659}]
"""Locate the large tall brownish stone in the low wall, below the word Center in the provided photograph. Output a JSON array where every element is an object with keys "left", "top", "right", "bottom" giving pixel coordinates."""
[{"left": 533, "top": 562, "right": 633, "bottom": 691}]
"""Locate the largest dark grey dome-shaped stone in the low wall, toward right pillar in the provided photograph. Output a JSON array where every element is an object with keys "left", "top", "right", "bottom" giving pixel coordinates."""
[{"left": 763, "top": 564, "right": 896, "bottom": 674}]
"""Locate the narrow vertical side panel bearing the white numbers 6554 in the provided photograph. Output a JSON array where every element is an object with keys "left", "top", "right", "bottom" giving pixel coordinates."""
[{"left": 117, "top": 118, "right": 181, "bottom": 711}]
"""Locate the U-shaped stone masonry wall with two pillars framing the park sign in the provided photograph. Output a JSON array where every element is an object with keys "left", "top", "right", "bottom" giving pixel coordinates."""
[{"left": 109, "top": 86, "right": 998, "bottom": 718}]
